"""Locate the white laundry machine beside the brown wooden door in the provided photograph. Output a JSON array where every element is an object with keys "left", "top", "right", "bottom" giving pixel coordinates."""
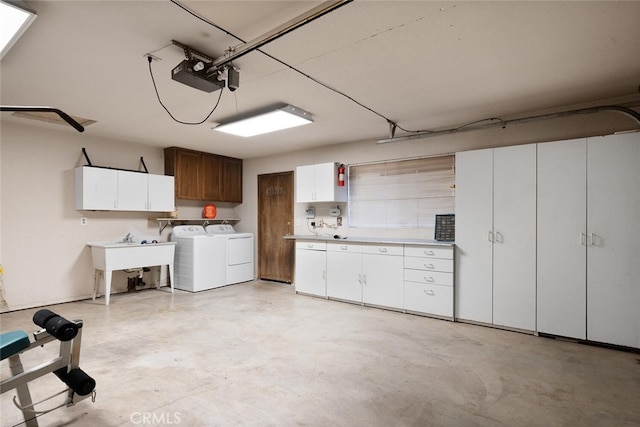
[{"left": 206, "top": 224, "right": 254, "bottom": 285}]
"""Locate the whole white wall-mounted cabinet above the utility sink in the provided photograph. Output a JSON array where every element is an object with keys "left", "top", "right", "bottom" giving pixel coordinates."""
[{"left": 74, "top": 166, "right": 175, "bottom": 212}]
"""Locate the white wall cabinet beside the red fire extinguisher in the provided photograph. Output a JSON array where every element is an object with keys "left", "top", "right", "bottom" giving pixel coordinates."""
[{"left": 296, "top": 163, "right": 347, "bottom": 203}]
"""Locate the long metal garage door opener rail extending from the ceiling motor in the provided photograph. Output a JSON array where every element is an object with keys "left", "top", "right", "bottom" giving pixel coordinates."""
[{"left": 207, "top": 0, "right": 353, "bottom": 72}]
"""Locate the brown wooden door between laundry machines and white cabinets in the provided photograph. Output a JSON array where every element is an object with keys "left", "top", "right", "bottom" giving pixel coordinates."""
[{"left": 258, "top": 171, "right": 295, "bottom": 283}]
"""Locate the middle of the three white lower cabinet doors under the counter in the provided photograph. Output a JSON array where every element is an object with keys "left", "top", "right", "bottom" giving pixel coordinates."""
[{"left": 327, "top": 249, "right": 362, "bottom": 303}]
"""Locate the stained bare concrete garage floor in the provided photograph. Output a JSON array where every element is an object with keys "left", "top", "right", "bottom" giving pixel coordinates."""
[{"left": 0, "top": 282, "right": 640, "bottom": 427}]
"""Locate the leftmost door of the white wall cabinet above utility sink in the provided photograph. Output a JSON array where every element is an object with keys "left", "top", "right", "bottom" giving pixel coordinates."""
[{"left": 74, "top": 167, "right": 118, "bottom": 211}]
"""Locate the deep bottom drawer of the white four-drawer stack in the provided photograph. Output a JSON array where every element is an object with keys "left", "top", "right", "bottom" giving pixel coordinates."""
[{"left": 404, "top": 282, "right": 453, "bottom": 317}]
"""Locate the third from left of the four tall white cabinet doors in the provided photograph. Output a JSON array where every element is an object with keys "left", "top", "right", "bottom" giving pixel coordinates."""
[{"left": 536, "top": 139, "right": 587, "bottom": 339}]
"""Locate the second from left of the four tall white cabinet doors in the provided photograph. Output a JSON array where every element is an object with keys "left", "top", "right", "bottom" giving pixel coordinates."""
[{"left": 493, "top": 144, "right": 536, "bottom": 331}]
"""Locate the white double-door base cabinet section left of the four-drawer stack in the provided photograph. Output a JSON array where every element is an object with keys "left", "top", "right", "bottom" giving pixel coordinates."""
[{"left": 327, "top": 243, "right": 404, "bottom": 310}]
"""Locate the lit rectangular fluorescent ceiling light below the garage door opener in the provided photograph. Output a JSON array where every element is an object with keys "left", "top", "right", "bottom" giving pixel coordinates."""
[{"left": 215, "top": 105, "right": 313, "bottom": 137}]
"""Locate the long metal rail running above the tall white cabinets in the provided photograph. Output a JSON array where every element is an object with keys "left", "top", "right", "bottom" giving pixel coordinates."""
[{"left": 377, "top": 105, "right": 640, "bottom": 144}]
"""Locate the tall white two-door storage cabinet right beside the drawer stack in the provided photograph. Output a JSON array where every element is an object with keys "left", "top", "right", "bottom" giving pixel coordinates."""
[{"left": 456, "top": 145, "right": 536, "bottom": 331}]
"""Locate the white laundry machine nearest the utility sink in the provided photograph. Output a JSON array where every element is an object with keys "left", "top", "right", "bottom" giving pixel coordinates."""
[{"left": 171, "top": 225, "right": 227, "bottom": 292}]
